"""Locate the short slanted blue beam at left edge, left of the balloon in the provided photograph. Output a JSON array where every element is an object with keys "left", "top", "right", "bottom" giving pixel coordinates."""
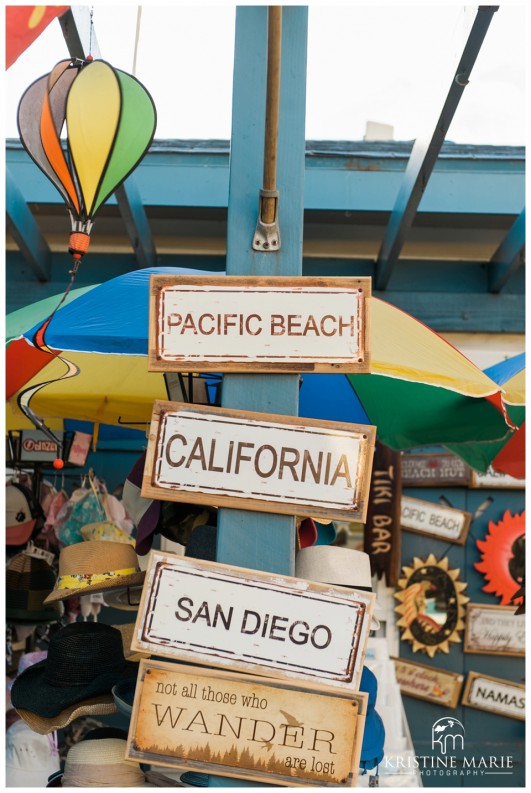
[{"left": 6, "top": 168, "right": 51, "bottom": 282}]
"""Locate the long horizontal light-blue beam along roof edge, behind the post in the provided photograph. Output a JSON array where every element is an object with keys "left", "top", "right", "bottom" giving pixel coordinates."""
[{"left": 6, "top": 140, "right": 525, "bottom": 215}]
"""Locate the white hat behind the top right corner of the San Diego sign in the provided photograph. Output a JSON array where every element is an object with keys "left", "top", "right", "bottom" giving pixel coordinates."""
[{"left": 295, "top": 545, "right": 380, "bottom": 630}]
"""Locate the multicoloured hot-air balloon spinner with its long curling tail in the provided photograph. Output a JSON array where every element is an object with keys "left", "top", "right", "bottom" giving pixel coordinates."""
[{"left": 17, "top": 55, "right": 156, "bottom": 454}]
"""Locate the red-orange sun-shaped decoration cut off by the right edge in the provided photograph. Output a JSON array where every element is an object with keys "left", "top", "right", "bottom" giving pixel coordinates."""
[{"left": 474, "top": 510, "right": 525, "bottom": 606}]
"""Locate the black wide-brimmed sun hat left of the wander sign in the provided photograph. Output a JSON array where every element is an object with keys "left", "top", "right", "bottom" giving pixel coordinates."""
[{"left": 11, "top": 622, "right": 138, "bottom": 726}]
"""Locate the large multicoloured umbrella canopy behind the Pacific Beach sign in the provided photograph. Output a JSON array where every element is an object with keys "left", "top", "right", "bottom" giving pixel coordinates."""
[{"left": 7, "top": 267, "right": 507, "bottom": 458}]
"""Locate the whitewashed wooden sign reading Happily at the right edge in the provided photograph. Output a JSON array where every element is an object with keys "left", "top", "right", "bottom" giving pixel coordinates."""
[{"left": 464, "top": 603, "right": 525, "bottom": 656}]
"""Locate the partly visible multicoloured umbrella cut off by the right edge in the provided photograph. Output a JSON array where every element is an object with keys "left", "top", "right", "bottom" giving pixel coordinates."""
[{"left": 448, "top": 353, "right": 525, "bottom": 479}]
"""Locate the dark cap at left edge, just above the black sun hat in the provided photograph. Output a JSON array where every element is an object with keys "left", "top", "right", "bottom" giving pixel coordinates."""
[{"left": 6, "top": 551, "right": 63, "bottom": 625}]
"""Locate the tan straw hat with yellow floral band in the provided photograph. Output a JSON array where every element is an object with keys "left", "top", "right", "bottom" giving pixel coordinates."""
[{"left": 44, "top": 540, "right": 145, "bottom": 603}]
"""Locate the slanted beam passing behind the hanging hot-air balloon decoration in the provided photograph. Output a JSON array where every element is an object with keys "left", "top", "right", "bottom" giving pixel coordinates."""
[{"left": 59, "top": 6, "right": 156, "bottom": 267}]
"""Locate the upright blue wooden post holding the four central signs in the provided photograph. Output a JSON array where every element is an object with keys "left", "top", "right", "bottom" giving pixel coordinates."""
[{"left": 209, "top": 6, "right": 308, "bottom": 787}]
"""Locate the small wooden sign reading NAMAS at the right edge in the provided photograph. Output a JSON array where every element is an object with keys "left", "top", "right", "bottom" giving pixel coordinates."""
[{"left": 461, "top": 672, "right": 525, "bottom": 721}]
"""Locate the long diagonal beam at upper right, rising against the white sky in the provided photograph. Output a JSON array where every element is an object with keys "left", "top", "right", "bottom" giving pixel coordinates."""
[{"left": 374, "top": 6, "right": 498, "bottom": 289}]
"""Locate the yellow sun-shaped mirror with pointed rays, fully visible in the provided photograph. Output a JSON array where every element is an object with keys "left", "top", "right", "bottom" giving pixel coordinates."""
[{"left": 394, "top": 553, "right": 470, "bottom": 658}]
